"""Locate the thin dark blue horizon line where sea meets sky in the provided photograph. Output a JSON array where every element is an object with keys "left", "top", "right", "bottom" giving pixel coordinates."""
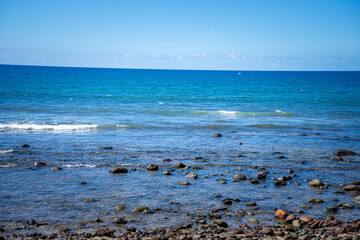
[{"left": 0, "top": 63, "right": 360, "bottom": 72}]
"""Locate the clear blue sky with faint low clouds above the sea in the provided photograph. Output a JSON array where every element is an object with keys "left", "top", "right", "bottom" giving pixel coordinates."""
[{"left": 0, "top": 0, "right": 360, "bottom": 71}]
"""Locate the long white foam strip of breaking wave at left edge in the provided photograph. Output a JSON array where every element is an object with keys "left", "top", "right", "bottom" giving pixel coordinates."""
[{"left": 0, "top": 123, "right": 98, "bottom": 131}]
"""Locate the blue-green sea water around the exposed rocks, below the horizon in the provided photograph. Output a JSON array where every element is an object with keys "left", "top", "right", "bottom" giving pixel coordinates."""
[{"left": 0, "top": 65, "right": 360, "bottom": 232}]
